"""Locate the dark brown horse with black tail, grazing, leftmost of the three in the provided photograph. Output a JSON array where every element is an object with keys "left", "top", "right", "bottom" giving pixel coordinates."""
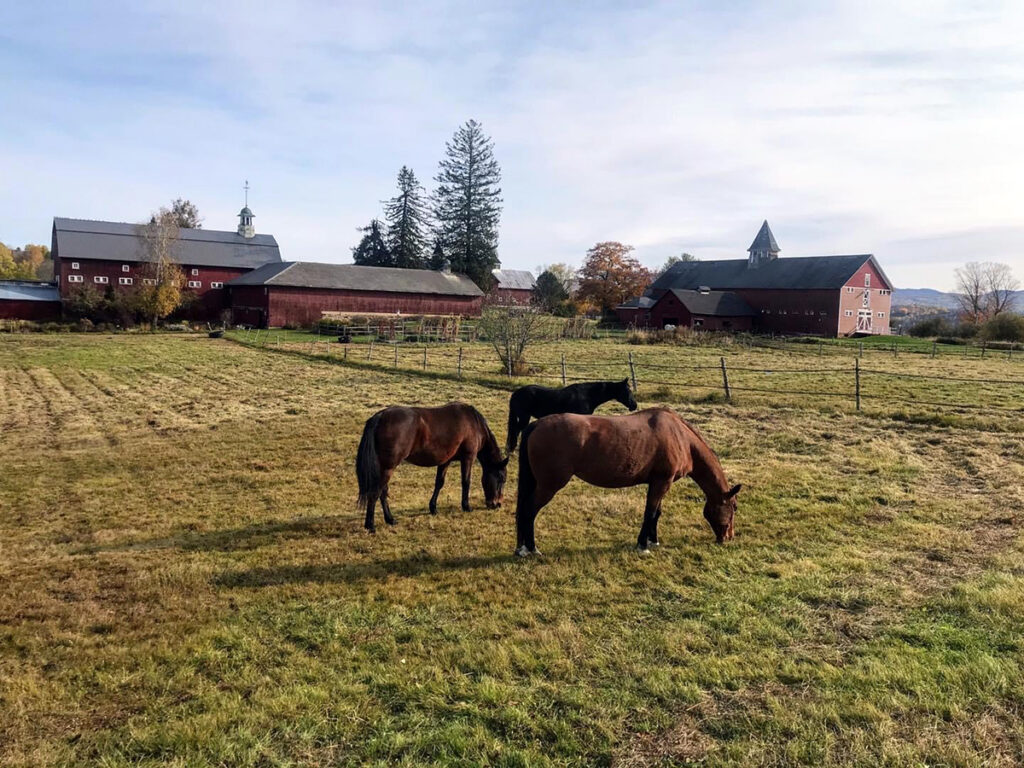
[{"left": 355, "top": 402, "right": 509, "bottom": 532}]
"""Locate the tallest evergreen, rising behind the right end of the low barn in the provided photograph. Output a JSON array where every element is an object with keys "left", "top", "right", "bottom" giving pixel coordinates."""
[{"left": 434, "top": 120, "right": 502, "bottom": 290}]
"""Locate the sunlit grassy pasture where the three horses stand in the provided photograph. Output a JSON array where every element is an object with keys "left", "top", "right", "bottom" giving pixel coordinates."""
[{"left": 0, "top": 335, "right": 1024, "bottom": 767}]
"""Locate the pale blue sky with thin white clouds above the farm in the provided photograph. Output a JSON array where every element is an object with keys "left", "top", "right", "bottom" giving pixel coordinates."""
[{"left": 0, "top": 0, "right": 1024, "bottom": 289}]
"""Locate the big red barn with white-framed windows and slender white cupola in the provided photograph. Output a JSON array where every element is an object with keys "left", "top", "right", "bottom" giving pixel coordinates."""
[{"left": 50, "top": 206, "right": 281, "bottom": 319}]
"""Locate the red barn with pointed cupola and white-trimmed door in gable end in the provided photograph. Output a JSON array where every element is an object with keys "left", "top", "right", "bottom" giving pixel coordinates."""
[{"left": 618, "top": 221, "right": 893, "bottom": 336}]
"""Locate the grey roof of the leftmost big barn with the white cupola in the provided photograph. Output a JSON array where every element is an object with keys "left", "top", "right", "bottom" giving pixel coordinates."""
[{"left": 53, "top": 217, "right": 281, "bottom": 269}]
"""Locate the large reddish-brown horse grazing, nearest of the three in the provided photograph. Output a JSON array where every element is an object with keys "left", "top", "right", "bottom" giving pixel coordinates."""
[{"left": 515, "top": 408, "right": 740, "bottom": 557}]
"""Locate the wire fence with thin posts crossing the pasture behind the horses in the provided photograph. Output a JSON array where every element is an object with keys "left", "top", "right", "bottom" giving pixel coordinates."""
[{"left": 230, "top": 331, "right": 1024, "bottom": 416}]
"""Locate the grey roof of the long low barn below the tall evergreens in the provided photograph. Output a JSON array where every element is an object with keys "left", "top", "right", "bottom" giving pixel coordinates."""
[{"left": 227, "top": 261, "right": 483, "bottom": 296}]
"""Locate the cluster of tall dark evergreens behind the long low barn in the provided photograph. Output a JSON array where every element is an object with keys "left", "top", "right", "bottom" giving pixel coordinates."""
[{"left": 352, "top": 120, "right": 502, "bottom": 290}]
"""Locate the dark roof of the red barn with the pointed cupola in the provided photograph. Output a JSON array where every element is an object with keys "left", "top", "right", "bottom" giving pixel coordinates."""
[{"left": 647, "top": 259, "right": 891, "bottom": 292}]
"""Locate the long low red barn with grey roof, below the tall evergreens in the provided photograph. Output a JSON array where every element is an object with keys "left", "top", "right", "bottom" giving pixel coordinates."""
[{"left": 227, "top": 261, "right": 483, "bottom": 328}]
